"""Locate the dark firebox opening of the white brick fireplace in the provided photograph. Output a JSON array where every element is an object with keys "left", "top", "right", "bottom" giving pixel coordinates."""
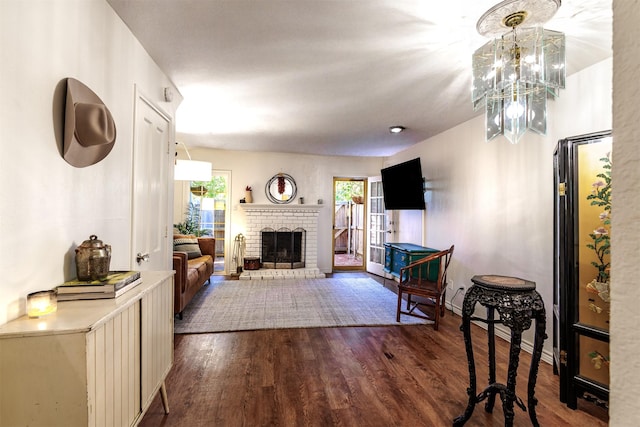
[{"left": 260, "top": 228, "right": 306, "bottom": 268}]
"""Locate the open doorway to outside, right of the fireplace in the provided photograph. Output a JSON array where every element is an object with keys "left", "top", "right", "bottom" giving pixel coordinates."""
[{"left": 332, "top": 178, "right": 367, "bottom": 271}]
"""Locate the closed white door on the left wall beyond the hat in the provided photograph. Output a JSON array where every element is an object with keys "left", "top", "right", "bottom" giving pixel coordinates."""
[{"left": 131, "top": 91, "right": 172, "bottom": 271}]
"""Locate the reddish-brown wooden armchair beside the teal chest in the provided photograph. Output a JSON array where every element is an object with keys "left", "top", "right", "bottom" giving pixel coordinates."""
[{"left": 396, "top": 245, "right": 453, "bottom": 331}]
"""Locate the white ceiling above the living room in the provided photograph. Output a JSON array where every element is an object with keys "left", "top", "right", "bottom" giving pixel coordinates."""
[{"left": 107, "top": 0, "right": 612, "bottom": 156}]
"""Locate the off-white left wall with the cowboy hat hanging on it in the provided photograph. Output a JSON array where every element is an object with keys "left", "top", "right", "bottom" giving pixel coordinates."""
[{"left": 0, "top": 0, "right": 180, "bottom": 324}]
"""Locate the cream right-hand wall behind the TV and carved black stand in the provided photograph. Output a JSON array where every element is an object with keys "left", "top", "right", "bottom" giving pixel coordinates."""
[{"left": 386, "top": 59, "right": 612, "bottom": 360}]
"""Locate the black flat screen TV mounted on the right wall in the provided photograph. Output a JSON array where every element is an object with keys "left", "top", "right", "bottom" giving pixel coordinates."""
[{"left": 380, "top": 158, "right": 425, "bottom": 210}]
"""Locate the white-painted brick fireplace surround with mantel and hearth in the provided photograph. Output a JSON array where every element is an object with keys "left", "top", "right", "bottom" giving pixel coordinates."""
[{"left": 240, "top": 203, "right": 325, "bottom": 279}]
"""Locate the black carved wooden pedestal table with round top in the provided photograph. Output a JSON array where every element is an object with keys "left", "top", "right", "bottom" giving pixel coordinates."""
[{"left": 453, "top": 275, "right": 547, "bottom": 426}]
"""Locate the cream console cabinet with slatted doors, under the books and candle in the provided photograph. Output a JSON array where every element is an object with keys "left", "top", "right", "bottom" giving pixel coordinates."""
[{"left": 0, "top": 271, "right": 174, "bottom": 427}]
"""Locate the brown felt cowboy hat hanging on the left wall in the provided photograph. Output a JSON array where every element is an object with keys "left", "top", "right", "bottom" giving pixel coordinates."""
[{"left": 62, "top": 78, "right": 116, "bottom": 168}]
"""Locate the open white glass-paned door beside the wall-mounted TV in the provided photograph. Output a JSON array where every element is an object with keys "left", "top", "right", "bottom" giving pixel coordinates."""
[{"left": 366, "top": 176, "right": 387, "bottom": 277}]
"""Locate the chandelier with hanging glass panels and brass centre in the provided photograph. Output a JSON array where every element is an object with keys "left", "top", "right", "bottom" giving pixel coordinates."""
[{"left": 472, "top": 0, "right": 565, "bottom": 144}]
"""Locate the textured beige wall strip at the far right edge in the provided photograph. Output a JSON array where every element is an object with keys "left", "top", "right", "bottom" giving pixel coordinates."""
[{"left": 609, "top": 0, "right": 640, "bottom": 427}]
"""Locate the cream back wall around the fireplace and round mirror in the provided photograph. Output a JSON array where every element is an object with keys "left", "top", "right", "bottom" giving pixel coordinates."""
[{"left": 174, "top": 147, "right": 382, "bottom": 273}]
